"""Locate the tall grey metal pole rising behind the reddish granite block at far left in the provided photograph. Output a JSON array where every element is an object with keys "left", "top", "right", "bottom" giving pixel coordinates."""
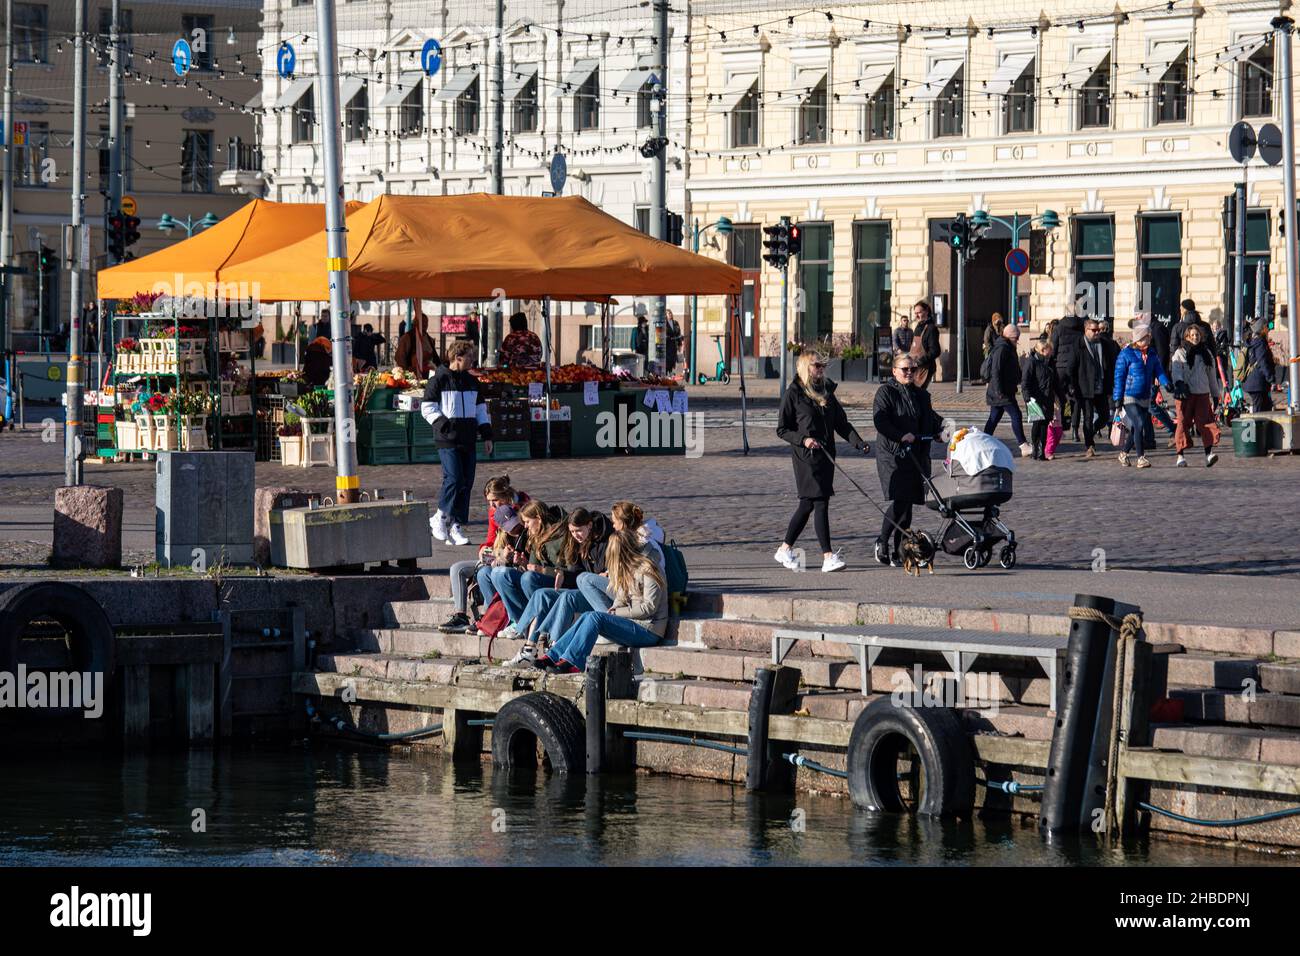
[{"left": 64, "top": 0, "right": 86, "bottom": 485}]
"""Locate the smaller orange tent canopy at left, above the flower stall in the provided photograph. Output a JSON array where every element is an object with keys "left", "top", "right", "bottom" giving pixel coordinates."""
[{"left": 96, "top": 199, "right": 361, "bottom": 299}]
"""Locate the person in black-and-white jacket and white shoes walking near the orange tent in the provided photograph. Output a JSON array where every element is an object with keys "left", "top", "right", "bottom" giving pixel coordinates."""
[{"left": 420, "top": 339, "right": 491, "bottom": 545}]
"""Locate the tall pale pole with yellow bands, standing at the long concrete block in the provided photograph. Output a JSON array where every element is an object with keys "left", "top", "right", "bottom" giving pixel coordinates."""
[{"left": 316, "top": 0, "right": 358, "bottom": 503}]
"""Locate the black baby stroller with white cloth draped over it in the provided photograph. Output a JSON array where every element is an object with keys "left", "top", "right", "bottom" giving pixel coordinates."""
[{"left": 922, "top": 429, "right": 1015, "bottom": 571}]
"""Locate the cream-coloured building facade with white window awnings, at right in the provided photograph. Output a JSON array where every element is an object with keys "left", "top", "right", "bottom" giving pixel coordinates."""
[{"left": 686, "top": 0, "right": 1286, "bottom": 377}]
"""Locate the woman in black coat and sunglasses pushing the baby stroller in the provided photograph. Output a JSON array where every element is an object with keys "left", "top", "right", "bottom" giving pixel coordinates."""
[{"left": 871, "top": 354, "right": 953, "bottom": 567}]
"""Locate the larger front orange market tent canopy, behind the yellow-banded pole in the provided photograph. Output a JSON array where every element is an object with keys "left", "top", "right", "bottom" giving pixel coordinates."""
[{"left": 222, "top": 194, "right": 741, "bottom": 302}]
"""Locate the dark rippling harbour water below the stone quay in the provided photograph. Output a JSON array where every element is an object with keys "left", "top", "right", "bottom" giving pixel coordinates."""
[{"left": 0, "top": 745, "right": 1287, "bottom": 866}]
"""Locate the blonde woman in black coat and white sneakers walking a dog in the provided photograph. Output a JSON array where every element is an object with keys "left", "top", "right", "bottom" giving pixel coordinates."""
[{"left": 776, "top": 352, "right": 871, "bottom": 571}]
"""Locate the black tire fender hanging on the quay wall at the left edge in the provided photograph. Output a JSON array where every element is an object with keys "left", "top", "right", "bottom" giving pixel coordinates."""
[{"left": 0, "top": 581, "right": 116, "bottom": 685}]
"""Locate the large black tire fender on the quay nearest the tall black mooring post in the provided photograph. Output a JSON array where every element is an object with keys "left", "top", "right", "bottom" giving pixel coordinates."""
[{"left": 848, "top": 696, "right": 975, "bottom": 817}]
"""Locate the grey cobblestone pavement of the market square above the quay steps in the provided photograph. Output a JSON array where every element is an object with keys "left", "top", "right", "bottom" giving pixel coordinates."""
[{"left": 0, "top": 386, "right": 1300, "bottom": 626}]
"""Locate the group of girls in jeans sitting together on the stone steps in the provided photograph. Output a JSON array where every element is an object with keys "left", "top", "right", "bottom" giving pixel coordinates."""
[{"left": 442, "top": 476, "right": 670, "bottom": 674}]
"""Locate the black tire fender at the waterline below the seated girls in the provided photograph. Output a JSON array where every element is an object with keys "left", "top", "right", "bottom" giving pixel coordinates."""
[{"left": 491, "top": 692, "right": 586, "bottom": 774}]
